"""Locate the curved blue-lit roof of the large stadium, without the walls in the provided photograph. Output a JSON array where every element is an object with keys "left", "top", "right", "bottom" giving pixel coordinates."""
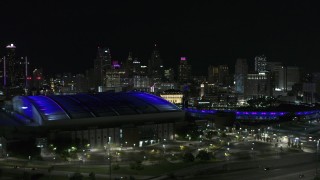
[{"left": 13, "top": 92, "right": 181, "bottom": 124}]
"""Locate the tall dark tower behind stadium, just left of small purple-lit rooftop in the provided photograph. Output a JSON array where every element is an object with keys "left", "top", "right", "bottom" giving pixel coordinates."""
[{"left": 94, "top": 47, "right": 111, "bottom": 88}]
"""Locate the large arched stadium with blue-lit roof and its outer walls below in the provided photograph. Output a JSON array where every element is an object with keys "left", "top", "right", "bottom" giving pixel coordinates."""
[{"left": 12, "top": 92, "right": 185, "bottom": 146}]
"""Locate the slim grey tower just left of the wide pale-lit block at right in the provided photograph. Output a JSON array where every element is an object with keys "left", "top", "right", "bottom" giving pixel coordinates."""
[{"left": 234, "top": 58, "right": 248, "bottom": 94}]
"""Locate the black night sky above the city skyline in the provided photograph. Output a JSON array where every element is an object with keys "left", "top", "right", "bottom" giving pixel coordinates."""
[{"left": 0, "top": 0, "right": 320, "bottom": 75}]
